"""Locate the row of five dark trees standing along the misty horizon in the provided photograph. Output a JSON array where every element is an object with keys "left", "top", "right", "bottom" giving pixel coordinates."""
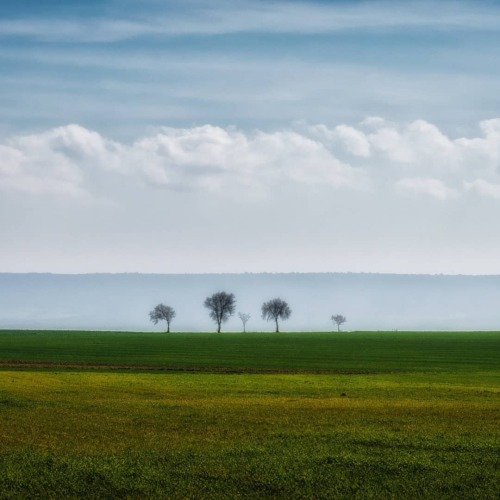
[{"left": 149, "top": 292, "right": 346, "bottom": 333}]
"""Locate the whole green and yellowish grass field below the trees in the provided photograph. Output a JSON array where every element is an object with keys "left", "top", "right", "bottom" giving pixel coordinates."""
[{"left": 0, "top": 331, "right": 500, "bottom": 499}]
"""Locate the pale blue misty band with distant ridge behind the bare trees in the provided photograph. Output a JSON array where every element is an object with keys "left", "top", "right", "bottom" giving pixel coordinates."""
[{"left": 0, "top": 273, "right": 500, "bottom": 331}]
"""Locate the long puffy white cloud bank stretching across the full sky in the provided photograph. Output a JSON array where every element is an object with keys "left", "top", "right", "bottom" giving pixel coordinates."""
[{"left": 0, "top": 117, "right": 500, "bottom": 202}]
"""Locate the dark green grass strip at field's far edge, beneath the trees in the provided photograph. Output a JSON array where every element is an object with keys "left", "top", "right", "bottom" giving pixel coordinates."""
[{"left": 0, "top": 330, "right": 500, "bottom": 373}]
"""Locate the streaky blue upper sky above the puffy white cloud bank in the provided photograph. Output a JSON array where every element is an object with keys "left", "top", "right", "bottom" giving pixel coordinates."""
[{"left": 0, "top": 0, "right": 500, "bottom": 137}]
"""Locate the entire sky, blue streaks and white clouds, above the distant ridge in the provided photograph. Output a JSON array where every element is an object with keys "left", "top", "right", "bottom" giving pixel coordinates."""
[{"left": 0, "top": 0, "right": 500, "bottom": 274}]
